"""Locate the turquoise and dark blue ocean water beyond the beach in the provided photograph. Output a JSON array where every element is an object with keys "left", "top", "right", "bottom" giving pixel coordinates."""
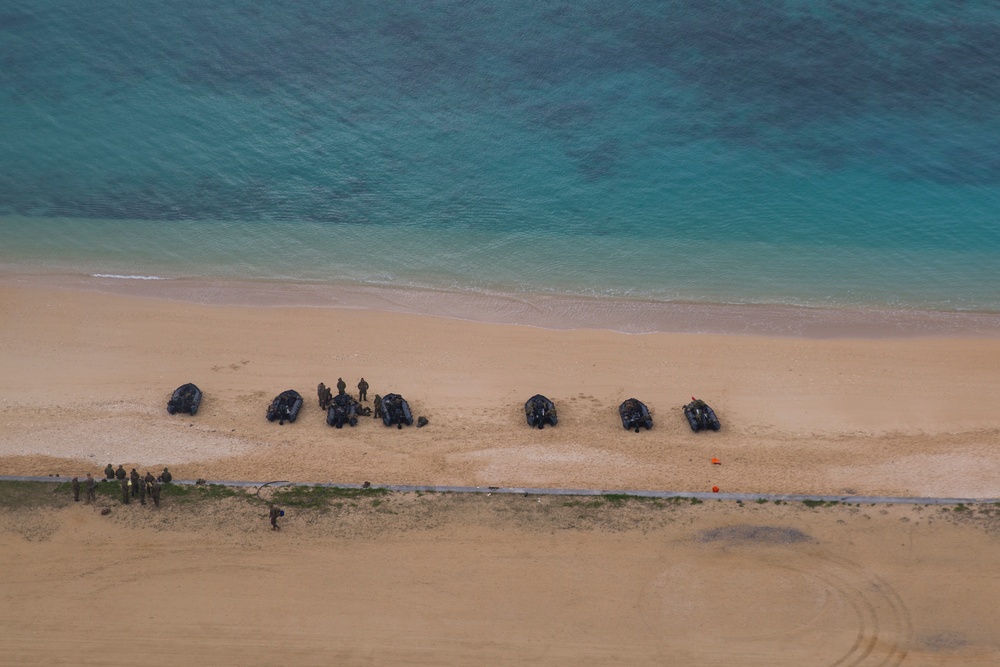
[{"left": 0, "top": 0, "right": 1000, "bottom": 320}]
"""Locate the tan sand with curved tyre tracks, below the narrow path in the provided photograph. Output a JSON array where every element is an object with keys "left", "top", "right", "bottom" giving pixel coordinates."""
[{"left": 0, "top": 489, "right": 1000, "bottom": 667}]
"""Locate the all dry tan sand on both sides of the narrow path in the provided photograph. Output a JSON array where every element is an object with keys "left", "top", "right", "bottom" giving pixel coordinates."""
[{"left": 0, "top": 282, "right": 1000, "bottom": 665}]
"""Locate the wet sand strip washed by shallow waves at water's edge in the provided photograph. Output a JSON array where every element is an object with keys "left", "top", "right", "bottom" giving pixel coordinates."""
[{"left": 0, "top": 270, "right": 1000, "bottom": 339}]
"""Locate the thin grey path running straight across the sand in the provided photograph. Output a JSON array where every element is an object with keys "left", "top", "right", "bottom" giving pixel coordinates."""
[{"left": 0, "top": 475, "right": 1000, "bottom": 505}]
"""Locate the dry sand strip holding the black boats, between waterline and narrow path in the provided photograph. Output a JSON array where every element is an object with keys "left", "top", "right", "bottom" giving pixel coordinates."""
[{"left": 0, "top": 287, "right": 1000, "bottom": 497}]
